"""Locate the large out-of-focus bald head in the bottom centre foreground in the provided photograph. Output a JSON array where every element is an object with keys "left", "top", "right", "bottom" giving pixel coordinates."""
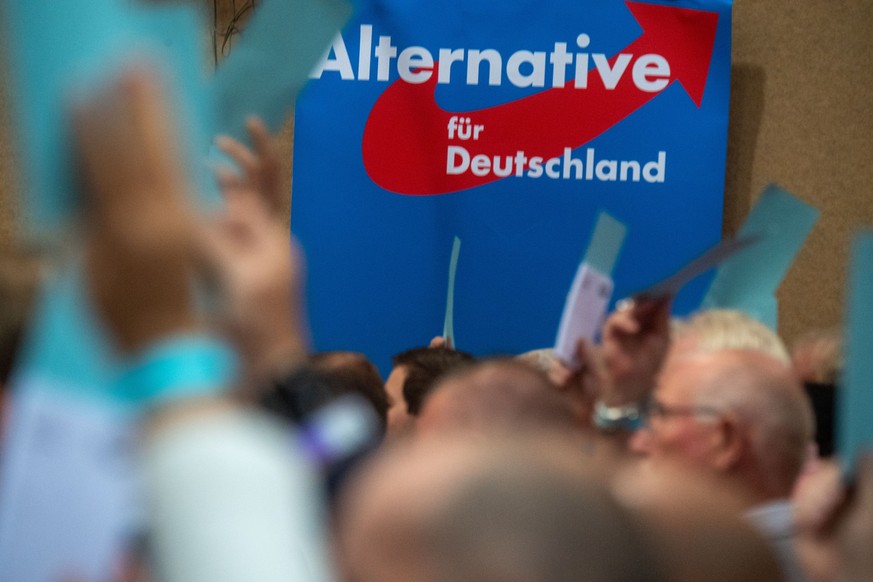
[{"left": 339, "top": 439, "right": 660, "bottom": 582}]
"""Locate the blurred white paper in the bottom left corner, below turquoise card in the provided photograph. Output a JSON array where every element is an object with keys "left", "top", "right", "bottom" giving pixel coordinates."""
[{"left": 0, "top": 380, "right": 139, "bottom": 582}]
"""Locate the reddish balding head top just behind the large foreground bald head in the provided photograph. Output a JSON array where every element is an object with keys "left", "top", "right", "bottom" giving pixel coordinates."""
[{"left": 418, "top": 360, "right": 577, "bottom": 434}]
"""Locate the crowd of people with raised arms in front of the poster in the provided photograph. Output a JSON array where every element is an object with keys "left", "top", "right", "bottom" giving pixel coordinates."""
[{"left": 0, "top": 68, "right": 860, "bottom": 582}]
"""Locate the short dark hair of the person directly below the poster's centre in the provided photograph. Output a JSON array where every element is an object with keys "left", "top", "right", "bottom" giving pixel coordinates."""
[{"left": 391, "top": 347, "right": 475, "bottom": 416}]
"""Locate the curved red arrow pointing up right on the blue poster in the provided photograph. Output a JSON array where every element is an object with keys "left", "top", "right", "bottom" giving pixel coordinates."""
[{"left": 363, "top": 2, "right": 718, "bottom": 195}]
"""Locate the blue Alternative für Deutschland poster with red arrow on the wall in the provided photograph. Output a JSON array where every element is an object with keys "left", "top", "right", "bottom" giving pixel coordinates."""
[{"left": 291, "top": 0, "right": 731, "bottom": 370}]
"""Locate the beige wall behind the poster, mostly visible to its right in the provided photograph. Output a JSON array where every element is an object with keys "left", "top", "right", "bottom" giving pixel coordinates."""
[{"left": 0, "top": 0, "right": 873, "bottom": 341}]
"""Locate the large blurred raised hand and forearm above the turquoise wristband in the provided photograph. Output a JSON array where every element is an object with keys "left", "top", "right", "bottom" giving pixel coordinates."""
[{"left": 73, "top": 66, "right": 198, "bottom": 351}]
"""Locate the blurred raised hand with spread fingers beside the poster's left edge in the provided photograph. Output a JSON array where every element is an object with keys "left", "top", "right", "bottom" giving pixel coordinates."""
[{"left": 202, "top": 120, "right": 308, "bottom": 388}]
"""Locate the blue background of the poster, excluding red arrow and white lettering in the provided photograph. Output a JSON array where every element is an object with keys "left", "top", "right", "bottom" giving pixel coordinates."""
[{"left": 292, "top": 0, "right": 731, "bottom": 372}]
